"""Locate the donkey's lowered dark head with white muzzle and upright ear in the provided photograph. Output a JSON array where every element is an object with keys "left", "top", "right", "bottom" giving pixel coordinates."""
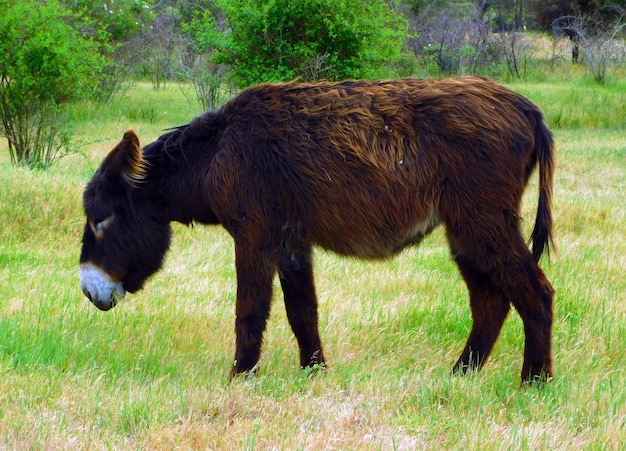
[{"left": 80, "top": 131, "right": 171, "bottom": 310}]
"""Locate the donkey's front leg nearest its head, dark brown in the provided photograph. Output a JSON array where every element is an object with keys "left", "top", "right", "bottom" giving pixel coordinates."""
[{"left": 231, "top": 243, "right": 276, "bottom": 377}]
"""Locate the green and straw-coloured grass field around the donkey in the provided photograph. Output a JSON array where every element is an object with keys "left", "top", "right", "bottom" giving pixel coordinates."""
[{"left": 0, "top": 76, "right": 626, "bottom": 450}]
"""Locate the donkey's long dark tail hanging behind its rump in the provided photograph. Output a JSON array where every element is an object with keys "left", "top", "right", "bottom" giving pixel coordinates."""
[{"left": 530, "top": 117, "right": 555, "bottom": 262}]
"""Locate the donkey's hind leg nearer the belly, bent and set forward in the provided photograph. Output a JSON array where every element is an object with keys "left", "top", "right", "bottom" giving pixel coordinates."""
[{"left": 452, "top": 253, "right": 510, "bottom": 374}]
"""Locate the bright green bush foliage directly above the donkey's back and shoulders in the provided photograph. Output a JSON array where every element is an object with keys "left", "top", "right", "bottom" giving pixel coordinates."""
[{"left": 216, "top": 0, "right": 407, "bottom": 86}]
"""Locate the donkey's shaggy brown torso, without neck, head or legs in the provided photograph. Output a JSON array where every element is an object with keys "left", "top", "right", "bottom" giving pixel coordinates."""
[{"left": 214, "top": 78, "right": 551, "bottom": 258}]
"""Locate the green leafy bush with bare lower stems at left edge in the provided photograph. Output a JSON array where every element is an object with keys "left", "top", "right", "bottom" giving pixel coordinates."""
[{"left": 0, "top": 0, "right": 105, "bottom": 167}]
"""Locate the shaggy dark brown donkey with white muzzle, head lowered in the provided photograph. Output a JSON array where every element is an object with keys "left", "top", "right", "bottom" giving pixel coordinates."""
[{"left": 80, "top": 77, "right": 554, "bottom": 382}]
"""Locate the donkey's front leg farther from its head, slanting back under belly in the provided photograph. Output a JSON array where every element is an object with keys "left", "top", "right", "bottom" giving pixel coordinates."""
[{"left": 278, "top": 246, "right": 324, "bottom": 368}]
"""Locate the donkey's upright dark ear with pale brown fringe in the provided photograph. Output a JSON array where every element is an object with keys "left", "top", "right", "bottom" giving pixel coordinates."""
[{"left": 103, "top": 130, "right": 147, "bottom": 188}]
